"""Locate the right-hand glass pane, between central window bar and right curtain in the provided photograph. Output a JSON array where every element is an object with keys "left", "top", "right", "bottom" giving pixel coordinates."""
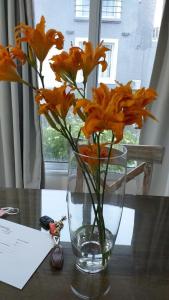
[{"left": 98, "top": 0, "right": 164, "bottom": 143}]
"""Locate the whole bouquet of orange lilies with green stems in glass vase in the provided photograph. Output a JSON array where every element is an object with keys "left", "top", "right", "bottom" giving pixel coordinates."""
[{"left": 0, "top": 16, "right": 156, "bottom": 270}]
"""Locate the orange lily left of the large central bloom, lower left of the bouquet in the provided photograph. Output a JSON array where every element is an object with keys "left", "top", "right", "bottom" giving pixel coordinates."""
[{"left": 35, "top": 86, "right": 75, "bottom": 119}]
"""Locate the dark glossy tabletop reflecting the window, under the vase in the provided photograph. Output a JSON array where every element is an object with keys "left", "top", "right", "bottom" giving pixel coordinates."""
[{"left": 0, "top": 189, "right": 169, "bottom": 300}]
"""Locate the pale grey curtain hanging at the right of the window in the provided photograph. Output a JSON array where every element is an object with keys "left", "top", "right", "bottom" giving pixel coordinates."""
[{"left": 140, "top": 1, "right": 169, "bottom": 196}]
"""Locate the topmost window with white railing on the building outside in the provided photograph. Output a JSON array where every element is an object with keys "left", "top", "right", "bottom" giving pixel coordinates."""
[{"left": 75, "top": 0, "right": 121, "bottom": 20}]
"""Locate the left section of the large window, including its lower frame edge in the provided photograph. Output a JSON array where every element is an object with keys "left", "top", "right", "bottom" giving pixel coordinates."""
[{"left": 34, "top": 0, "right": 89, "bottom": 166}]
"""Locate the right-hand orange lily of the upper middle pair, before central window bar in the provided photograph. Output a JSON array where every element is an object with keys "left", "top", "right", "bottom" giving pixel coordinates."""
[{"left": 81, "top": 41, "right": 110, "bottom": 82}]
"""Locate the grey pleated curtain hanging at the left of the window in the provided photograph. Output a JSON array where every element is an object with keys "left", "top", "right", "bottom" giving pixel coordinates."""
[{"left": 0, "top": 0, "right": 42, "bottom": 188}]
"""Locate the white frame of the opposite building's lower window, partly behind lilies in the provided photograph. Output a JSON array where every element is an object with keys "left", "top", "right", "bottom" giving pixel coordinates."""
[{"left": 75, "top": 37, "right": 118, "bottom": 84}]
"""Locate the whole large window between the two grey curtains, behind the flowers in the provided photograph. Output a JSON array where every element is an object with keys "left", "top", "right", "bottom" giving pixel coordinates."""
[{"left": 34, "top": 0, "right": 164, "bottom": 171}]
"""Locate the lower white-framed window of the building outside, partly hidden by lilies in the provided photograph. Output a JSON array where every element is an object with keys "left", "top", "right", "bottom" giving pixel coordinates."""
[{"left": 75, "top": 38, "right": 118, "bottom": 84}]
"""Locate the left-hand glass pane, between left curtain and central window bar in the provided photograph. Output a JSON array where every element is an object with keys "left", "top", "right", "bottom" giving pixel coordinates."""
[{"left": 34, "top": 0, "right": 89, "bottom": 162}]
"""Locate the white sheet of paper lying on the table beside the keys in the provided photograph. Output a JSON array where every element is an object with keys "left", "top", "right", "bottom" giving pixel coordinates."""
[{"left": 0, "top": 219, "right": 53, "bottom": 289}]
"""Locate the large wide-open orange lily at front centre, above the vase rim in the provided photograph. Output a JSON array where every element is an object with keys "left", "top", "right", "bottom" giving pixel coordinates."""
[{"left": 75, "top": 83, "right": 124, "bottom": 142}]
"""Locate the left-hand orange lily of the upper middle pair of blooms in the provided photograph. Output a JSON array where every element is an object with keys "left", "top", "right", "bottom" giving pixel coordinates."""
[{"left": 50, "top": 47, "right": 81, "bottom": 82}]
